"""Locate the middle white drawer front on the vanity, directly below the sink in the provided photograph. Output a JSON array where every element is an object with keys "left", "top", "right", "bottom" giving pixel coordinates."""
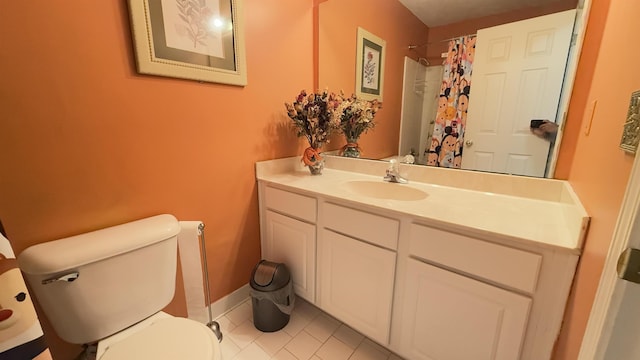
[{"left": 322, "top": 203, "right": 400, "bottom": 250}]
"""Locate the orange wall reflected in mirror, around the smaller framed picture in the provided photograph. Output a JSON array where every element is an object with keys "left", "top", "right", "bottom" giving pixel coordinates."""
[{"left": 318, "top": 0, "right": 428, "bottom": 159}]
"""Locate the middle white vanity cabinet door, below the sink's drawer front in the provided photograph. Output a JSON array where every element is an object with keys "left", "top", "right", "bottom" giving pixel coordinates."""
[{"left": 318, "top": 229, "right": 396, "bottom": 345}]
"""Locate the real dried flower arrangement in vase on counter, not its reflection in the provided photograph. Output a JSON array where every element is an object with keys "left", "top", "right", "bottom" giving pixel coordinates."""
[{"left": 284, "top": 90, "right": 344, "bottom": 171}]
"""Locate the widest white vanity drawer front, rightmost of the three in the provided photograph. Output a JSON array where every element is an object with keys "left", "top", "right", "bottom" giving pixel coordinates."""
[{"left": 409, "top": 224, "right": 542, "bottom": 293}]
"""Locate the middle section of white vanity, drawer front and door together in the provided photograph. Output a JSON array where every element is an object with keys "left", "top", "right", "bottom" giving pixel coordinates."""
[{"left": 318, "top": 203, "right": 399, "bottom": 345}]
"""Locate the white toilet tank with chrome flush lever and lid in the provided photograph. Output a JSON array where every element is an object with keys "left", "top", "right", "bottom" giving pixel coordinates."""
[{"left": 18, "top": 214, "right": 180, "bottom": 344}]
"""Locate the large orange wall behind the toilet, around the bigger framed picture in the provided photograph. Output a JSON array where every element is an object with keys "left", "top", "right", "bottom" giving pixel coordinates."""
[{"left": 0, "top": 0, "right": 313, "bottom": 359}]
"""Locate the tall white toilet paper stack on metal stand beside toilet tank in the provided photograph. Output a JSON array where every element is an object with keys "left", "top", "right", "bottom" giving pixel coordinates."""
[{"left": 178, "top": 221, "right": 210, "bottom": 324}]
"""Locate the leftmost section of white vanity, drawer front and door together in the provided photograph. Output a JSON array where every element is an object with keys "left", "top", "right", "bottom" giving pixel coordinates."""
[{"left": 261, "top": 186, "right": 316, "bottom": 303}]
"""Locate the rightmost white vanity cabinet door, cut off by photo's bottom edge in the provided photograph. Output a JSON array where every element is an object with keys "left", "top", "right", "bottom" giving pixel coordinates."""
[{"left": 400, "top": 259, "right": 531, "bottom": 360}]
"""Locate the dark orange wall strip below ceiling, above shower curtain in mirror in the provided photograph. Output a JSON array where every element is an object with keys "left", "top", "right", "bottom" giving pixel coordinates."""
[{"left": 427, "top": 0, "right": 578, "bottom": 64}]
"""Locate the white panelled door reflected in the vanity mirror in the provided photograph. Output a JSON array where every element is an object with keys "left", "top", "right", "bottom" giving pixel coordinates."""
[{"left": 462, "top": 10, "right": 576, "bottom": 177}]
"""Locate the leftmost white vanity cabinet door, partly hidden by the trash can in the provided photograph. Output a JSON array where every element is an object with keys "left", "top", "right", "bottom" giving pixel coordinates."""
[{"left": 262, "top": 210, "right": 316, "bottom": 303}]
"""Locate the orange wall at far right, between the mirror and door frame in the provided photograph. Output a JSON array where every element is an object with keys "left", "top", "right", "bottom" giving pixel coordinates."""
[{"left": 555, "top": 0, "right": 640, "bottom": 360}]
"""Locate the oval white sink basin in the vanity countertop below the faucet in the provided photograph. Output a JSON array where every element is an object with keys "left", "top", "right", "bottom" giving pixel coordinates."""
[{"left": 345, "top": 180, "right": 428, "bottom": 201}]
